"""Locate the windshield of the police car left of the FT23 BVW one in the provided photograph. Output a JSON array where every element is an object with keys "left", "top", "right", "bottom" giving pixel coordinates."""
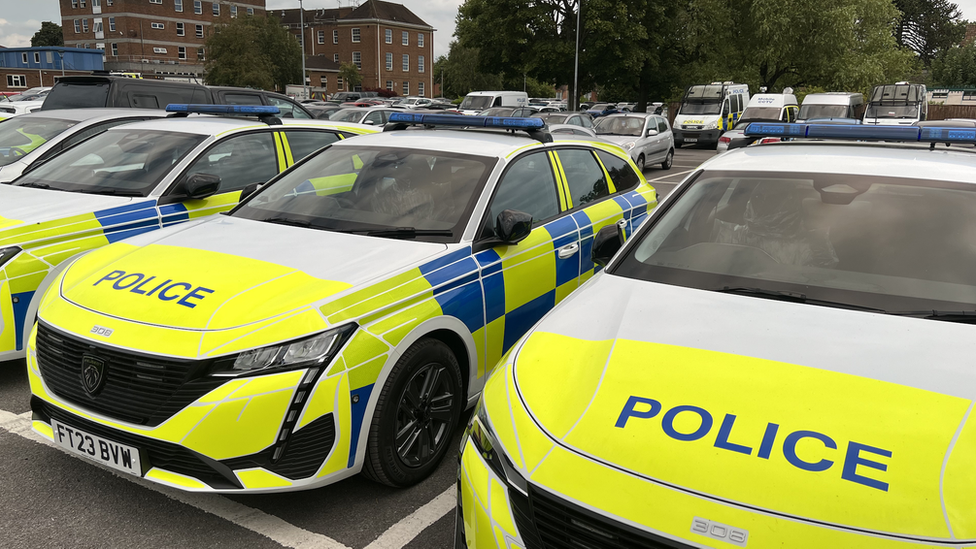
[{"left": 15, "top": 129, "right": 204, "bottom": 196}]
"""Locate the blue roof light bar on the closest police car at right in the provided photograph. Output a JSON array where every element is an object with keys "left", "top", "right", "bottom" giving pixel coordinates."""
[{"left": 745, "top": 122, "right": 976, "bottom": 144}]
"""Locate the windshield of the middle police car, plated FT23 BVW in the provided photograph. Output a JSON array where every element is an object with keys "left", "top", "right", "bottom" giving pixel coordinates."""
[{"left": 233, "top": 146, "right": 495, "bottom": 242}]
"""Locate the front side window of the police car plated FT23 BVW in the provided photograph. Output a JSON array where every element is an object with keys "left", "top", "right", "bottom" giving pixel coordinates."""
[{"left": 489, "top": 152, "right": 559, "bottom": 225}]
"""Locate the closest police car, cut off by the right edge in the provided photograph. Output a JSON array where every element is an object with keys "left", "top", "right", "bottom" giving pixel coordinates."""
[{"left": 457, "top": 123, "right": 976, "bottom": 549}]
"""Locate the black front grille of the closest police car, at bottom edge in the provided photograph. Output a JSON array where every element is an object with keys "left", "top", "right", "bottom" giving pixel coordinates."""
[{"left": 509, "top": 486, "right": 691, "bottom": 549}]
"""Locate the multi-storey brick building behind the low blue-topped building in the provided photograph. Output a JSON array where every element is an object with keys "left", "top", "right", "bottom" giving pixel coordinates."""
[{"left": 59, "top": 0, "right": 266, "bottom": 78}]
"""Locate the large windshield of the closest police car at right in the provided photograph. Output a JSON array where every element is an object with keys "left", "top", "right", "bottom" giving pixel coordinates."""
[{"left": 613, "top": 171, "right": 976, "bottom": 312}]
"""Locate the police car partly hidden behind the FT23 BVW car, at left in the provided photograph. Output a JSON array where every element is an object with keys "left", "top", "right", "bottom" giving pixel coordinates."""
[{"left": 0, "top": 105, "right": 376, "bottom": 361}]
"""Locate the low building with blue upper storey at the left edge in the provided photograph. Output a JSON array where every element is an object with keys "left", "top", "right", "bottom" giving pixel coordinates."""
[{"left": 0, "top": 47, "right": 102, "bottom": 92}]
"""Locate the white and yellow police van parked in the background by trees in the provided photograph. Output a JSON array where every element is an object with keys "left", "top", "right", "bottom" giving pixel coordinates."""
[{"left": 673, "top": 82, "right": 749, "bottom": 147}]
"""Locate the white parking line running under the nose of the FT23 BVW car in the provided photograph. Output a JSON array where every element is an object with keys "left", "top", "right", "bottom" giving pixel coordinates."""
[{"left": 0, "top": 410, "right": 352, "bottom": 549}]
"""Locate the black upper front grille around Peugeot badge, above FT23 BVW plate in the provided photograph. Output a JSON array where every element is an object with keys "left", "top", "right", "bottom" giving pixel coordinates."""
[{"left": 37, "top": 322, "right": 226, "bottom": 427}]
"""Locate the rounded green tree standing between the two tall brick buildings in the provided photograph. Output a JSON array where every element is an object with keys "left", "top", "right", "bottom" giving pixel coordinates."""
[{"left": 205, "top": 15, "right": 303, "bottom": 90}]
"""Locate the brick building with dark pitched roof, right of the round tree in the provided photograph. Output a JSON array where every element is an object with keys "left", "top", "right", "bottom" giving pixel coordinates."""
[{"left": 269, "top": 0, "right": 435, "bottom": 97}]
